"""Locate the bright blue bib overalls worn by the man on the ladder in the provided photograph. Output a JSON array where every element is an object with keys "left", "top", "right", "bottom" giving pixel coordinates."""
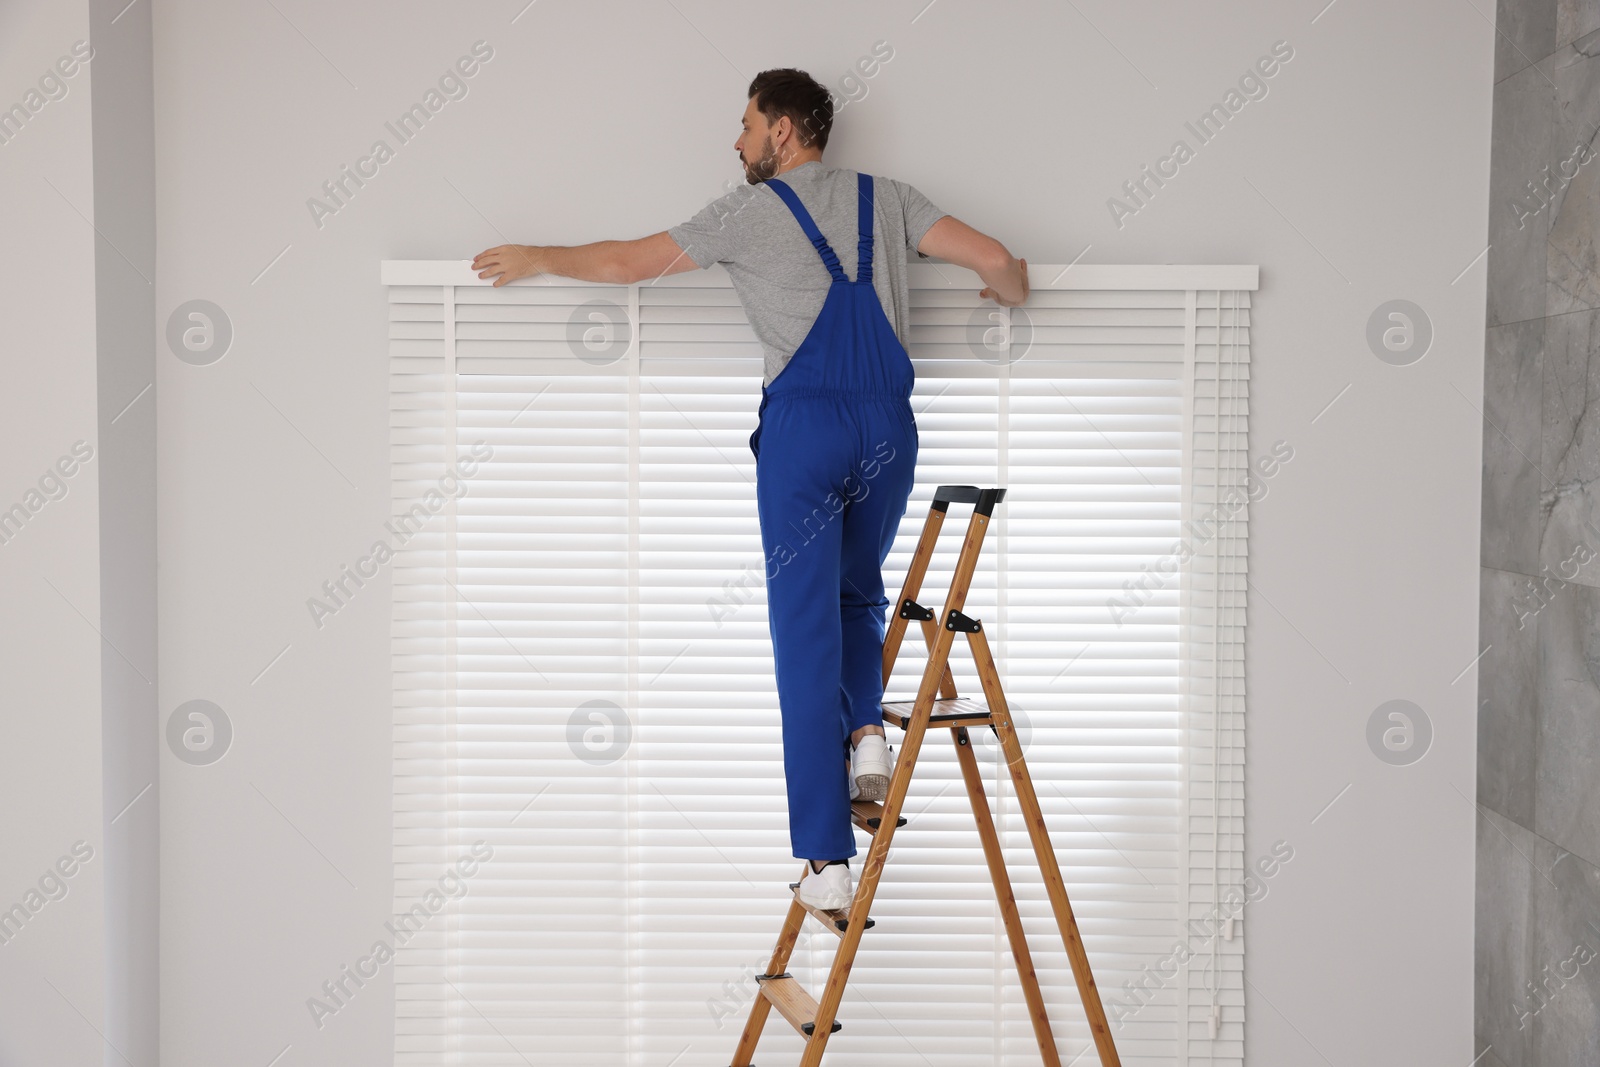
[{"left": 750, "top": 174, "right": 917, "bottom": 859}]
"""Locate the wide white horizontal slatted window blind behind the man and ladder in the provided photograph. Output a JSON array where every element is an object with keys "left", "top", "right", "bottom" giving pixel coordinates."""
[{"left": 384, "top": 261, "right": 1256, "bottom": 1067}]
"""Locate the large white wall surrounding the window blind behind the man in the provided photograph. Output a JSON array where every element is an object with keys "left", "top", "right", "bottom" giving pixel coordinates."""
[{"left": 150, "top": 0, "right": 1493, "bottom": 1067}]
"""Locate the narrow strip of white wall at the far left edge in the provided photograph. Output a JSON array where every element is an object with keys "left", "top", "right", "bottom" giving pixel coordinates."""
[{"left": 0, "top": 3, "right": 109, "bottom": 1067}]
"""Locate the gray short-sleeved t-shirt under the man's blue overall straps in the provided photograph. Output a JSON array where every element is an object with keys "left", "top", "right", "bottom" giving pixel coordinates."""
[{"left": 667, "top": 160, "right": 946, "bottom": 386}]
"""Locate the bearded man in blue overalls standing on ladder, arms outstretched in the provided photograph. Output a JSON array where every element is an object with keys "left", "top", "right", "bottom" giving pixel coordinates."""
[{"left": 472, "top": 69, "right": 1027, "bottom": 910}]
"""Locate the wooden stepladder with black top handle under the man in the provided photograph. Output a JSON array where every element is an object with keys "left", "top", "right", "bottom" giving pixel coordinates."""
[{"left": 731, "top": 485, "right": 1122, "bottom": 1067}]
